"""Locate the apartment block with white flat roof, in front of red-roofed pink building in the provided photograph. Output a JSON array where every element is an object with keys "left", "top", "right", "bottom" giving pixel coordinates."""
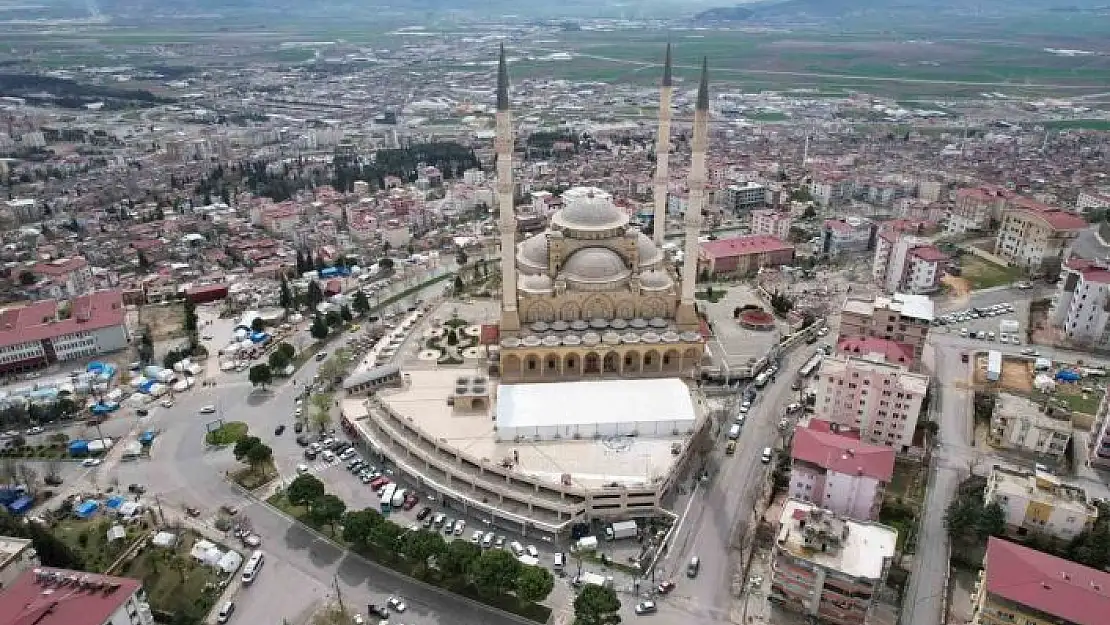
[{"left": 770, "top": 500, "right": 898, "bottom": 625}]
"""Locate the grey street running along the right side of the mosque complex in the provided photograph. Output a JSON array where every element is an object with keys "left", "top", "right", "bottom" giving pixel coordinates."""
[{"left": 664, "top": 347, "right": 810, "bottom": 623}]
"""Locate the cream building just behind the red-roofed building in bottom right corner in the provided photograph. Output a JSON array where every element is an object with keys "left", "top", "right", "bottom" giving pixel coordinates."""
[{"left": 983, "top": 464, "right": 1099, "bottom": 541}]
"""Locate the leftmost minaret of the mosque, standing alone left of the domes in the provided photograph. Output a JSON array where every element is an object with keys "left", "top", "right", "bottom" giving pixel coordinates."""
[{"left": 494, "top": 43, "right": 521, "bottom": 332}]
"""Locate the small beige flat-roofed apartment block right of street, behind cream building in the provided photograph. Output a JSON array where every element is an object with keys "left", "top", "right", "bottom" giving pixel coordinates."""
[{"left": 987, "top": 393, "right": 1071, "bottom": 463}]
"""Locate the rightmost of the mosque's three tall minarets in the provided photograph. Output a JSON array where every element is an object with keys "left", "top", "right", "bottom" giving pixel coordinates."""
[{"left": 675, "top": 58, "right": 709, "bottom": 330}]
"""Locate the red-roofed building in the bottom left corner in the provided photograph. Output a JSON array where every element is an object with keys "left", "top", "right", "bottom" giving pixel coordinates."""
[{"left": 0, "top": 567, "right": 154, "bottom": 625}]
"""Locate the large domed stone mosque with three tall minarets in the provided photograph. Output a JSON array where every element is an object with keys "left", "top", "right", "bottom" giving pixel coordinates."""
[{"left": 494, "top": 46, "right": 709, "bottom": 383}]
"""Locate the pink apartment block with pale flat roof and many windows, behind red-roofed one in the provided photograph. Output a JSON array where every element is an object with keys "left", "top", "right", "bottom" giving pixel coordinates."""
[{"left": 816, "top": 354, "right": 929, "bottom": 452}]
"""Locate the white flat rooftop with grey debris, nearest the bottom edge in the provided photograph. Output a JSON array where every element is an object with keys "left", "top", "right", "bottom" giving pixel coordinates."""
[{"left": 777, "top": 500, "right": 898, "bottom": 579}]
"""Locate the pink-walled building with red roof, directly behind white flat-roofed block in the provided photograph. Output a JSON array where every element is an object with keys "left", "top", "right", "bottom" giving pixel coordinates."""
[{"left": 789, "top": 420, "right": 895, "bottom": 521}]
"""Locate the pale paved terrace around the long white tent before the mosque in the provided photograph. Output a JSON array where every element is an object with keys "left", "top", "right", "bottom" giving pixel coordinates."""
[{"left": 379, "top": 367, "right": 683, "bottom": 487}]
